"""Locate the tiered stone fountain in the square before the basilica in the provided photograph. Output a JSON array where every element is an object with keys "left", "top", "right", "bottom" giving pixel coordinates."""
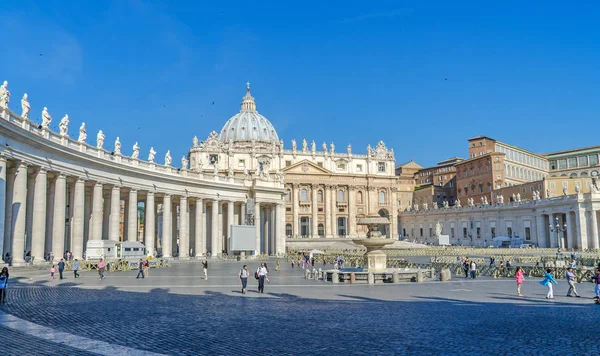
[{"left": 352, "top": 215, "right": 395, "bottom": 272}]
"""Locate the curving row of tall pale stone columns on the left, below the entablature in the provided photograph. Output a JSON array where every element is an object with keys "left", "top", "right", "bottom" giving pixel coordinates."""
[{"left": 0, "top": 155, "right": 285, "bottom": 265}]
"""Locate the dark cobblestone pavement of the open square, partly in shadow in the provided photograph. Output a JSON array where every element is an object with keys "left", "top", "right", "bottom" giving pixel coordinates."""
[{"left": 0, "top": 262, "right": 600, "bottom": 355}]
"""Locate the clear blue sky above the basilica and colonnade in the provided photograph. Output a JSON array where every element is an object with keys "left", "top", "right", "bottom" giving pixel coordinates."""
[{"left": 0, "top": 0, "right": 600, "bottom": 165}]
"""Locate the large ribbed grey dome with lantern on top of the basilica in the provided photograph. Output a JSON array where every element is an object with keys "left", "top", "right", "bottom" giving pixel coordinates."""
[{"left": 219, "top": 83, "right": 279, "bottom": 143}]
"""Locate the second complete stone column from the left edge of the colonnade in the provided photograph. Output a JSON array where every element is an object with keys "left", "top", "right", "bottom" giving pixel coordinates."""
[{"left": 31, "top": 168, "right": 48, "bottom": 264}]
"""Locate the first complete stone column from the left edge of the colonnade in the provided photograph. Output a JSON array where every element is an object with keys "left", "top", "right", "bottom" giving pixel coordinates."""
[{"left": 11, "top": 162, "right": 28, "bottom": 266}]
